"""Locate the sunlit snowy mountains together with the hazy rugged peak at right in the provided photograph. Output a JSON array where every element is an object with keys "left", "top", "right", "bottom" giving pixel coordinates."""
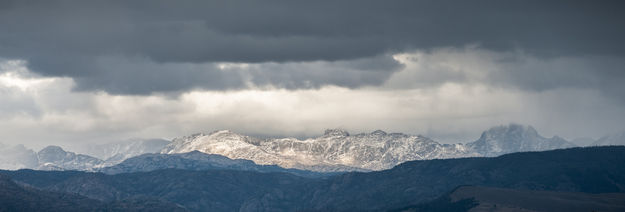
[{"left": 161, "top": 124, "right": 575, "bottom": 172}]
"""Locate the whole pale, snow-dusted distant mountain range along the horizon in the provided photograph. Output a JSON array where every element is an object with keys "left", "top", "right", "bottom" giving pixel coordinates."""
[{"left": 0, "top": 124, "right": 623, "bottom": 172}]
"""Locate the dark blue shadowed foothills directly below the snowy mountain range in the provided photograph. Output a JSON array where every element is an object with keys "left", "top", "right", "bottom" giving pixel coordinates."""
[{"left": 0, "top": 146, "right": 625, "bottom": 211}]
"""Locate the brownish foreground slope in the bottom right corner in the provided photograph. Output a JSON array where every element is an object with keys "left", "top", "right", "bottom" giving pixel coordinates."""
[{"left": 392, "top": 186, "right": 625, "bottom": 212}]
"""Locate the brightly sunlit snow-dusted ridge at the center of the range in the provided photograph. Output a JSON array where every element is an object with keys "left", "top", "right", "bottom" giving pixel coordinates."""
[{"left": 161, "top": 129, "right": 476, "bottom": 171}]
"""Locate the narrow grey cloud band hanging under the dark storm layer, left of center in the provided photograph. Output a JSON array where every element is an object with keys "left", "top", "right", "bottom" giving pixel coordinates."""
[{"left": 64, "top": 55, "right": 402, "bottom": 95}]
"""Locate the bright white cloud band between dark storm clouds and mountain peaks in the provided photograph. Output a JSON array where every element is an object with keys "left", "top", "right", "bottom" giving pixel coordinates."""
[{"left": 0, "top": 47, "right": 625, "bottom": 147}]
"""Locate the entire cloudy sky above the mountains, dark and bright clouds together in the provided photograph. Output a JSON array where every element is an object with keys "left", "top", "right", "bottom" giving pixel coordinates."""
[{"left": 0, "top": 0, "right": 625, "bottom": 147}]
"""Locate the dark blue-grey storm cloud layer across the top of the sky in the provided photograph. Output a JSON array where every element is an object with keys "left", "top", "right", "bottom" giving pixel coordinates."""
[{"left": 0, "top": 0, "right": 625, "bottom": 94}]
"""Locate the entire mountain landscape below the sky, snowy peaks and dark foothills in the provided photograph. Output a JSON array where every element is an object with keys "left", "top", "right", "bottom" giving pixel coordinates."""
[{"left": 0, "top": 124, "right": 625, "bottom": 211}]
